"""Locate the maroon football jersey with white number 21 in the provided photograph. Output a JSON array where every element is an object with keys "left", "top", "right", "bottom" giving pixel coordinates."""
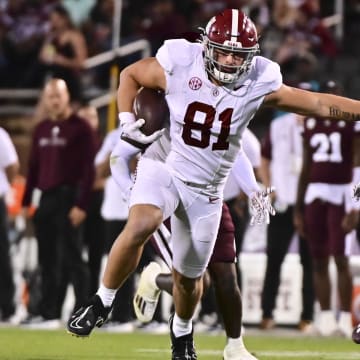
[{"left": 303, "top": 118, "right": 360, "bottom": 184}]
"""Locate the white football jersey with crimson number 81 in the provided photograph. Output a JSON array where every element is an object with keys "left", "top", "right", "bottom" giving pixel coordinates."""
[{"left": 156, "top": 39, "right": 282, "bottom": 184}]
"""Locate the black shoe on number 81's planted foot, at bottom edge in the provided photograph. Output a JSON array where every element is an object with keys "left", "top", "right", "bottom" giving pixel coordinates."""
[{"left": 169, "top": 314, "right": 197, "bottom": 360}]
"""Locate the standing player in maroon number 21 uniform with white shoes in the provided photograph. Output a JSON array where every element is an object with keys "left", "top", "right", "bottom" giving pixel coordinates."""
[{"left": 294, "top": 81, "right": 360, "bottom": 337}]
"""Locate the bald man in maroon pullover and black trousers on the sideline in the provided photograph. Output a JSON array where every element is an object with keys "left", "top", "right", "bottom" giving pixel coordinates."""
[{"left": 23, "top": 79, "right": 95, "bottom": 328}]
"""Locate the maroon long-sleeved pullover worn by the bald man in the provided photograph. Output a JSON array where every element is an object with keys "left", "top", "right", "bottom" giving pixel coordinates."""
[{"left": 23, "top": 114, "right": 96, "bottom": 210}]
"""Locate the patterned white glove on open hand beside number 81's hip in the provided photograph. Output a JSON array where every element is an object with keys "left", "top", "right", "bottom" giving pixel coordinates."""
[{"left": 249, "top": 187, "right": 276, "bottom": 226}]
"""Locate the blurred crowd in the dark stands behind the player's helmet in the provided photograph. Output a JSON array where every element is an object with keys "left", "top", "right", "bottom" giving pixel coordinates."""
[{"left": 0, "top": 0, "right": 360, "bottom": 98}]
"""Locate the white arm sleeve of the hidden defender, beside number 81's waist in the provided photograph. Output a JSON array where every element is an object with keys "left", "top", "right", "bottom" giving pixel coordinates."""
[{"left": 233, "top": 150, "right": 260, "bottom": 196}]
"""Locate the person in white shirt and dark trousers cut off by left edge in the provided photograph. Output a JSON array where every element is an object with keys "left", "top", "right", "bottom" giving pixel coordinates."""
[{"left": 0, "top": 128, "right": 19, "bottom": 322}]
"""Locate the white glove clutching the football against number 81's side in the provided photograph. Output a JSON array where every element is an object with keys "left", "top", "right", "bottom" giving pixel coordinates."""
[{"left": 121, "top": 119, "right": 165, "bottom": 148}]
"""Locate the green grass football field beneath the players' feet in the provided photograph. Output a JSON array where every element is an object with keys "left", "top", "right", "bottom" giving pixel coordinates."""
[{"left": 0, "top": 328, "right": 360, "bottom": 360}]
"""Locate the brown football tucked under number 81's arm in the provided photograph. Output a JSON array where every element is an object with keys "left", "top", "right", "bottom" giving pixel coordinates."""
[{"left": 134, "top": 88, "right": 169, "bottom": 135}]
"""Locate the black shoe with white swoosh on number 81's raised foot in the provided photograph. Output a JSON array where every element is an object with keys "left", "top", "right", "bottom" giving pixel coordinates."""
[{"left": 67, "top": 295, "right": 111, "bottom": 337}]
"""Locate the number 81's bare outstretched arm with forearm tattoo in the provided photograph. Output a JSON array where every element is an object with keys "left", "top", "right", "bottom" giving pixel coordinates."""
[{"left": 264, "top": 85, "right": 360, "bottom": 121}]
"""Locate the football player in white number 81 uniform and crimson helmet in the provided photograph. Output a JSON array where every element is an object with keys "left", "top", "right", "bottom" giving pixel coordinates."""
[{"left": 68, "top": 9, "right": 360, "bottom": 360}]
